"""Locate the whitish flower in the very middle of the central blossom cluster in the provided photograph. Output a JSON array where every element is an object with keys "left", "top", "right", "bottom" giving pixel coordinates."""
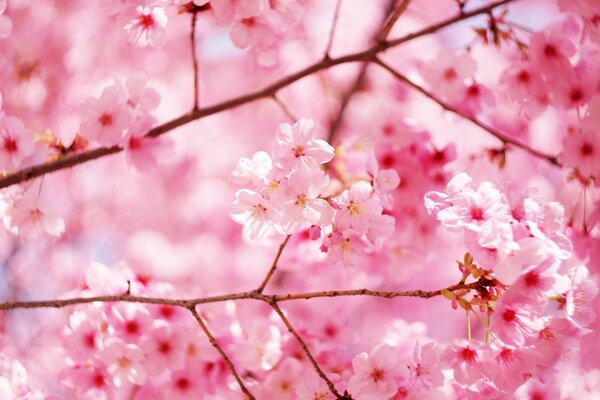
[{"left": 280, "top": 162, "right": 333, "bottom": 234}]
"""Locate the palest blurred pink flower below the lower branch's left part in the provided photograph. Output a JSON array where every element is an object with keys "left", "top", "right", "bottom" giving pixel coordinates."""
[{"left": 98, "top": 337, "right": 146, "bottom": 388}]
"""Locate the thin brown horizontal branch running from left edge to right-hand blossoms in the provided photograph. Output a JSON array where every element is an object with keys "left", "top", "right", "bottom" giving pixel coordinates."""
[{"left": 0, "top": 280, "right": 490, "bottom": 311}]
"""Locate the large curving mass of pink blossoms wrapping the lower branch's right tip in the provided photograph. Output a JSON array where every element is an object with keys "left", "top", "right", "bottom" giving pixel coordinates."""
[{"left": 340, "top": 174, "right": 598, "bottom": 400}]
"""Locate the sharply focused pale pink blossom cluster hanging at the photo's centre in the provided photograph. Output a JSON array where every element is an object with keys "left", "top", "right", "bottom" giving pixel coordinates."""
[{"left": 231, "top": 119, "right": 399, "bottom": 265}]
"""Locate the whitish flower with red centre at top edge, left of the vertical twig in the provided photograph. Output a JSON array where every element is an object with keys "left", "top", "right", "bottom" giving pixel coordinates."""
[{"left": 123, "top": 6, "right": 168, "bottom": 47}]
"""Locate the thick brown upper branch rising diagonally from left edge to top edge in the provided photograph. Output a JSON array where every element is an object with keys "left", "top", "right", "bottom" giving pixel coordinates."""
[{"left": 0, "top": 0, "right": 516, "bottom": 189}]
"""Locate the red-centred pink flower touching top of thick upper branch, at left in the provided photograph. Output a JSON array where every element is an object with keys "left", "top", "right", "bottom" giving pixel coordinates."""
[{"left": 79, "top": 84, "right": 132, "bottom": 146}]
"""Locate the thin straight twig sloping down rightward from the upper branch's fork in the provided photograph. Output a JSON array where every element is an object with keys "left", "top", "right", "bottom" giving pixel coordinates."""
[{"left": 373, "top": 57, "right": 561, "bottom": 167}]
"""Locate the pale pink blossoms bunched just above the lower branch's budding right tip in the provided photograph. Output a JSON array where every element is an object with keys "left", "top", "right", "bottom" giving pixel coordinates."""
[{"left": 425, "top": 173, "right": 572, "bottom": 284}]
